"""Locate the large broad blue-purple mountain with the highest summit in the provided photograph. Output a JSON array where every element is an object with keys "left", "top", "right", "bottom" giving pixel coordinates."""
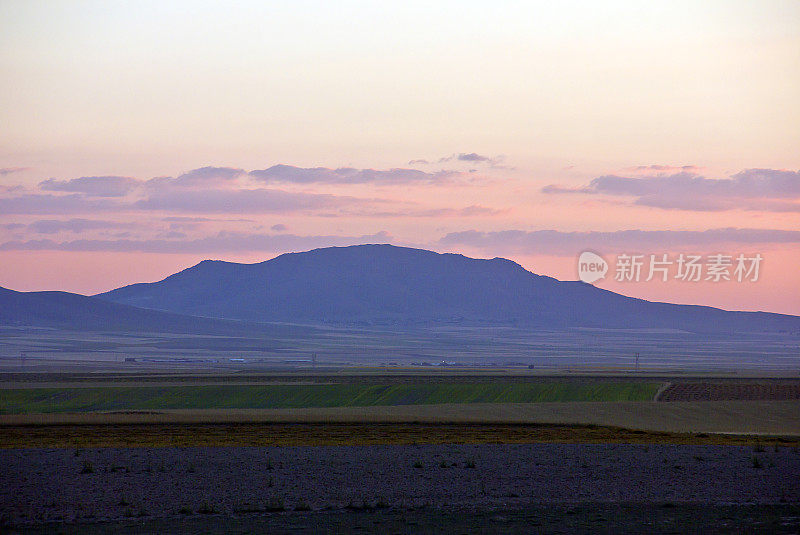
[{"left": 96, "top": 245, "right": 800, "bottom": 332}]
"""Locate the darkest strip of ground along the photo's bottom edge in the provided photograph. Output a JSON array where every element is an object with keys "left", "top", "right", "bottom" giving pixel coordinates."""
[{"left": 15, "top": 503, "right": 800, "bottom": 535}]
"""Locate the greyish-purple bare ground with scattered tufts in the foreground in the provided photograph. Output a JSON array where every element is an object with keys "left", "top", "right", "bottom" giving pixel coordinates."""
[{"left": 0, "top": 444, "right": 800, "bottom": 531}]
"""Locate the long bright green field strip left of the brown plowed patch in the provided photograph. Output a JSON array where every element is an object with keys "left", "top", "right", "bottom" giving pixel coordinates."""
[{"left": 0, "top": 382, "right": 661, "bottom": 414}]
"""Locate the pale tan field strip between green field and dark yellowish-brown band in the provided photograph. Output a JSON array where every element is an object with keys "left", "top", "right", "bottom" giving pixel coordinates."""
[{"left": 0, "top": 401, "right": 800, "bottom": 447}]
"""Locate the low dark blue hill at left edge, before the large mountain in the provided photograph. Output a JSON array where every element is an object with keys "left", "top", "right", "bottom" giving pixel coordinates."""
[{"left": 0, "top": 287, "right": 280, "bottom": 334}]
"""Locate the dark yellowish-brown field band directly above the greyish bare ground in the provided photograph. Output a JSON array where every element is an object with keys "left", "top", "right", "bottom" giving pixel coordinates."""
[{"left": 0, "top": 423, "right": 800, "bottom": 448}]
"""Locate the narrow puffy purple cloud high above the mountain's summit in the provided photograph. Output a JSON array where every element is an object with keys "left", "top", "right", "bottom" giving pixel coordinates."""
[{"left": 250, "top": 164, "right": 457, "bottom": 184}]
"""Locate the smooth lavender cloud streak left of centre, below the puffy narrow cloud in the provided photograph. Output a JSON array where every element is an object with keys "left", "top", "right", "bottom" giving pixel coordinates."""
[{"left": 134, "top": 189, "right": 364, "bottom": 213}]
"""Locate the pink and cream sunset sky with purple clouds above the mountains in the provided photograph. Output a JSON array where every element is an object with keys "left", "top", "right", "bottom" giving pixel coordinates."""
[{"left": 0, "top": 0, "right": 800, "bottom": 314}]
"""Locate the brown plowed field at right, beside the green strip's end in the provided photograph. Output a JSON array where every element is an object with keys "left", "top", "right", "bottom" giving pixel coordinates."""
[{"left": 658, "top": 381, "right": 800, "bottom": 401}]
